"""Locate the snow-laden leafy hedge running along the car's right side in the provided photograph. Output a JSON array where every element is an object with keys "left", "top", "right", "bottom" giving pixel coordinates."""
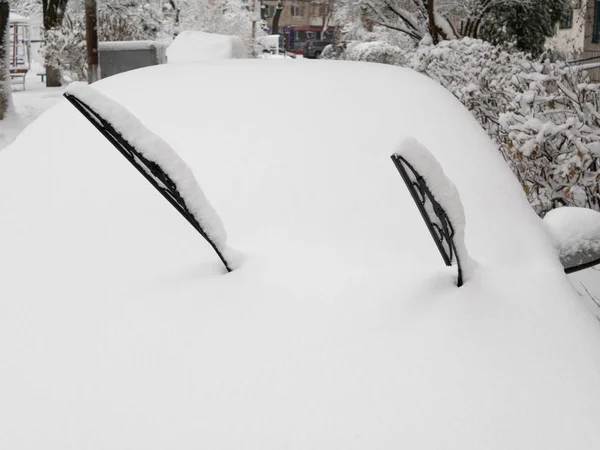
[{"left": 409, "top": 38, "right": 600, "bottom": 216}]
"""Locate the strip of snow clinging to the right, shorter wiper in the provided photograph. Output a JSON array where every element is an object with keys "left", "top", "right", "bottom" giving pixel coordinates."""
[{"left": 396, "top": 137, "right": 474, "bottom": 281}]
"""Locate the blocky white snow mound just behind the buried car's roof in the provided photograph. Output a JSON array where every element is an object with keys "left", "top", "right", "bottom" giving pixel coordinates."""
[{"left": 167, "top": 31, "right": 248, "bottom": 63}]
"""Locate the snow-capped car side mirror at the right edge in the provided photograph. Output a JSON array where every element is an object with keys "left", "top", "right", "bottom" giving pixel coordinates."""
[{"left": 544, "top": 207, "right": 600, "bottom": 273}]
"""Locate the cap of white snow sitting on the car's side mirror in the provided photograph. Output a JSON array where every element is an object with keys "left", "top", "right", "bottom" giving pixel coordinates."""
[{"left": 544, "top": 207, "right": 600, "bottom": 256}]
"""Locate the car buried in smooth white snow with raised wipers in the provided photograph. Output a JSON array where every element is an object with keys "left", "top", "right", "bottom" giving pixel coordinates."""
[{"left": 0, "top": 60, "right": 600, "bottom": 450}]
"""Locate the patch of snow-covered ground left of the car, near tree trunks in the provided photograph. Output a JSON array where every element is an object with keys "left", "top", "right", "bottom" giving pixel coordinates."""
[{"left": 0, "top": 65, "right": 65, "bottom": 150}]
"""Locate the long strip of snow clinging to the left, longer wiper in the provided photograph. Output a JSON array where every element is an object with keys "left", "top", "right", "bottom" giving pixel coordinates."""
[{"left": 67, "top": 83, "right": 230, "bottom": 266}]
